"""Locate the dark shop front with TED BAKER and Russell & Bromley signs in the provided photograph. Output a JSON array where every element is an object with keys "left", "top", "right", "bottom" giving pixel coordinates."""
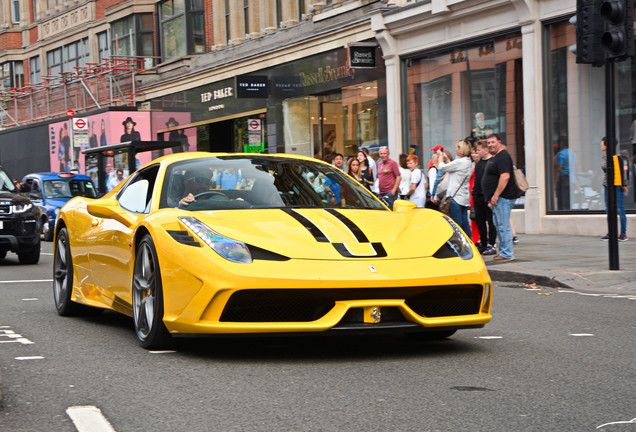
[{"left": 147, "top": 42, "right": 387, "bottom": 163}]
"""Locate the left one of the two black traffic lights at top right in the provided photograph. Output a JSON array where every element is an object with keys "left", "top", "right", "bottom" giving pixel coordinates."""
[{"left": 570, "top": 0, "right": 605, "bottom": 65}]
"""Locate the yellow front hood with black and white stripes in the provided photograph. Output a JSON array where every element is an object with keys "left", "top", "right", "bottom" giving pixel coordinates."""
[{"left": 186, "top": 208, "right": 452, "bottom": 260}]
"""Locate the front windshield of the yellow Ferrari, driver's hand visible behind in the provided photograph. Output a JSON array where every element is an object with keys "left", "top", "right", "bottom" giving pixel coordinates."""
[{"left": 159, "top": 155, "right": 386, "bottom": 210}]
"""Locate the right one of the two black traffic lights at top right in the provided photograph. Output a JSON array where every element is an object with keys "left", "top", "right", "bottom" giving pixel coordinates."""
[{"left": 600, "top": 0, "right": 634, "bottom": 59}]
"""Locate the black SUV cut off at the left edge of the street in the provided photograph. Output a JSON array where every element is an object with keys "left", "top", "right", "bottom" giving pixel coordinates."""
[{"left": 0, "top": 166, "right": 40, "bottom": 264}]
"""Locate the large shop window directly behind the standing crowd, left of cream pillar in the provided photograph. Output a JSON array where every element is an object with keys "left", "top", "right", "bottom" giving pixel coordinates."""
[{"left": 403, "top": 33, "right": 525, "bottom": 199}]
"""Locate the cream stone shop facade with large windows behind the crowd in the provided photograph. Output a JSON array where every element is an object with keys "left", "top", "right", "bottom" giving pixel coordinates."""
[{"left": 372, "top": 0, "right": 636, "bottom": 236}]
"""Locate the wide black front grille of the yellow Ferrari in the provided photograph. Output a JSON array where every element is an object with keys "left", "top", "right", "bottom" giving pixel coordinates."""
[{"left": 221, "top": 285, "right": 482, "bottom": 322}]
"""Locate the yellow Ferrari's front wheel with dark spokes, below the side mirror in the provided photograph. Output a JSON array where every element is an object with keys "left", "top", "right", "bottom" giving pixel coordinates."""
[{"left": 132, "top": 235, "right": 171, "bottom": 349}]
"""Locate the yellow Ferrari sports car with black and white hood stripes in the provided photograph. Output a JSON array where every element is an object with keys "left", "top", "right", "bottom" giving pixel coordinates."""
[{"left": 53, "top": 153, "right": 492, "bottom": 348}]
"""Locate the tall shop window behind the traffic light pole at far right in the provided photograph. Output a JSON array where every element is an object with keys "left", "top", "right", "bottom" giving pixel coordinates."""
[{"left": 544, "top": 21, "right": 636, "bottom": 212}]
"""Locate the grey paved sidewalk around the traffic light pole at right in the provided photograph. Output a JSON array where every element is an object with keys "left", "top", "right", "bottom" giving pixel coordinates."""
[{"left": 484, "top": 234, "right": 636, "bottom": 295}]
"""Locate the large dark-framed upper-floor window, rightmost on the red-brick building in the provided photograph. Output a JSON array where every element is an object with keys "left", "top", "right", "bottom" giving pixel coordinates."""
[{"left": 159, "top": 0, "right": 205, "bottom": 60}]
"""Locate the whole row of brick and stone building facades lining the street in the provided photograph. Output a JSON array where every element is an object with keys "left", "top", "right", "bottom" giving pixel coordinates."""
[{"left": 0, "top": 0, "right": 636, "bottom": 236}]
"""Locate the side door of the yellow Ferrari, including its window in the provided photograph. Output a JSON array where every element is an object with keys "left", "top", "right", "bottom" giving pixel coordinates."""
[{"left": 88, "top": 165, "right": 159, "bottom": 303}]
